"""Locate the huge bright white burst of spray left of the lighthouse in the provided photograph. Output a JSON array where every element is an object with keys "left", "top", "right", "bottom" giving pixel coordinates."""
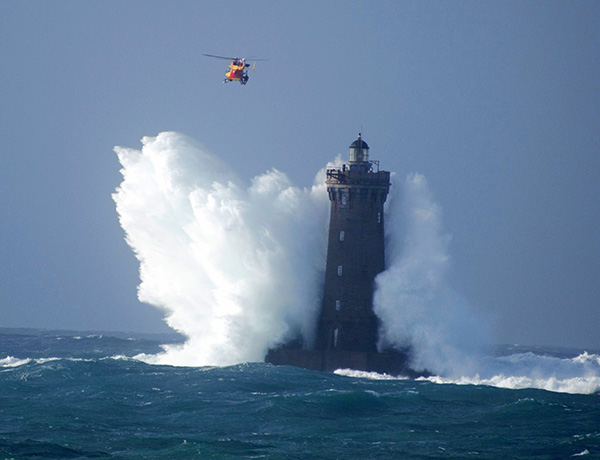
[{"left": 113, "top": 132, "right": 328, "bottom": 365}]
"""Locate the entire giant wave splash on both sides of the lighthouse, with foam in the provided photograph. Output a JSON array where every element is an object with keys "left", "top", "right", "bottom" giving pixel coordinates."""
[{"left": 113, "top": 132, "right": 600, "bottom": 392}]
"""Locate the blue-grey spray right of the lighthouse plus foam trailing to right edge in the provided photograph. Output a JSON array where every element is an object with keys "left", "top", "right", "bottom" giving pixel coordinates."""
[{"left": 374, "top": 174, "right": 600, "bottom": 393}]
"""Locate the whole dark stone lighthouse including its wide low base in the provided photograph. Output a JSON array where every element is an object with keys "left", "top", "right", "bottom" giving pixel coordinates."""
[{"left": 266, "top": 134, "right": 412, "bottom": 375}]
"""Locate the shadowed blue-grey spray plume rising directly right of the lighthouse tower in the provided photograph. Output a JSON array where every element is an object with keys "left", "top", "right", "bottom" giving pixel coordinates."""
[{"left": 374, "top": 174, "right": 489, "bottom": 375}]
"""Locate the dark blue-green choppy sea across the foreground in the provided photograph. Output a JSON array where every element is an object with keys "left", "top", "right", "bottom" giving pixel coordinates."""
[{"left": 0, "top": 329, "right": 600, "bottom": 460}]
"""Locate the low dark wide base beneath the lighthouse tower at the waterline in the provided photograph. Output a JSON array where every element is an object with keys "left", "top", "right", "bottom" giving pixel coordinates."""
[{"left": 265, "top": 348, "right": 423, "bottom": 378}]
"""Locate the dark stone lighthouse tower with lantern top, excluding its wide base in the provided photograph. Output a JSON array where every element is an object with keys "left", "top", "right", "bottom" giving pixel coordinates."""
[{"left": 317, "top": 134, "right": 390, "bottom": 352}]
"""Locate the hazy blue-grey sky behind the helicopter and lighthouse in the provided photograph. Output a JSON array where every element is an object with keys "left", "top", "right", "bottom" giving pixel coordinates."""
[{"left": 0, "top": 0, "right": 600, "bottom": 348}]
